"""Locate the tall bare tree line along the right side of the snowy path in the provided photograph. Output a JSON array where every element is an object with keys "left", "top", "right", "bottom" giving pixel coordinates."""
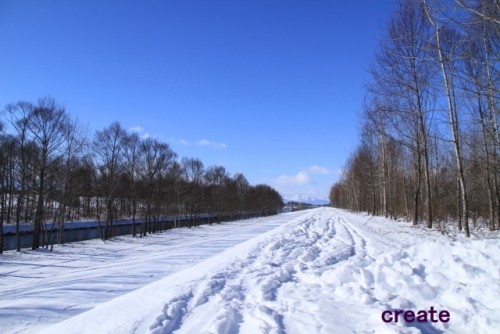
[{"left": 330, "top": 0, "right": 500, "bottom": 237}]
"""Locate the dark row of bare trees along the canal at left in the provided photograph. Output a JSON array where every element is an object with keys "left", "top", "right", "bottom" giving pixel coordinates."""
[{"left": 0, "top": 97, "right": 283, "bottom": 253}]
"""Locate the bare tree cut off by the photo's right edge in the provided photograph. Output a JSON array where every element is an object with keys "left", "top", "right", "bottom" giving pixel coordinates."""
[{"left": 457, "top": 0, "right": 500, "bottom": 230}]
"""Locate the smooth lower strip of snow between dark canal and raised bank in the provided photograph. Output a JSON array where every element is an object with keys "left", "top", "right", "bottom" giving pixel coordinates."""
[{"left": 0, "top": 213, "right": 303, "bottom": 333}]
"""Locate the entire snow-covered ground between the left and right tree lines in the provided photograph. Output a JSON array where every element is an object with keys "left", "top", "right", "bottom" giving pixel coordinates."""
[{"left": 0, "top": 208, "right": 500, "bottom": 334}]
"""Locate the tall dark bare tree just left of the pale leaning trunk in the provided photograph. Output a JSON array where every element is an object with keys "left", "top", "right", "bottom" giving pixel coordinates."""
[{"left": 370, "top": 0, "right": 433, "bottom": 228}]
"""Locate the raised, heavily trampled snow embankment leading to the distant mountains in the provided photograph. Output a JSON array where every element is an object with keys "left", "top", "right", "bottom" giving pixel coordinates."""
[{"left": 0, "top": 208, "right": 500, "bottom": 334}]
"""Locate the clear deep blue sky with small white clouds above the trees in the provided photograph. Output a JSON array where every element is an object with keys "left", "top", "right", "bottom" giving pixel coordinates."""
[{"left": 0, "top": 0, "right": 395, "bottom": 197}]
